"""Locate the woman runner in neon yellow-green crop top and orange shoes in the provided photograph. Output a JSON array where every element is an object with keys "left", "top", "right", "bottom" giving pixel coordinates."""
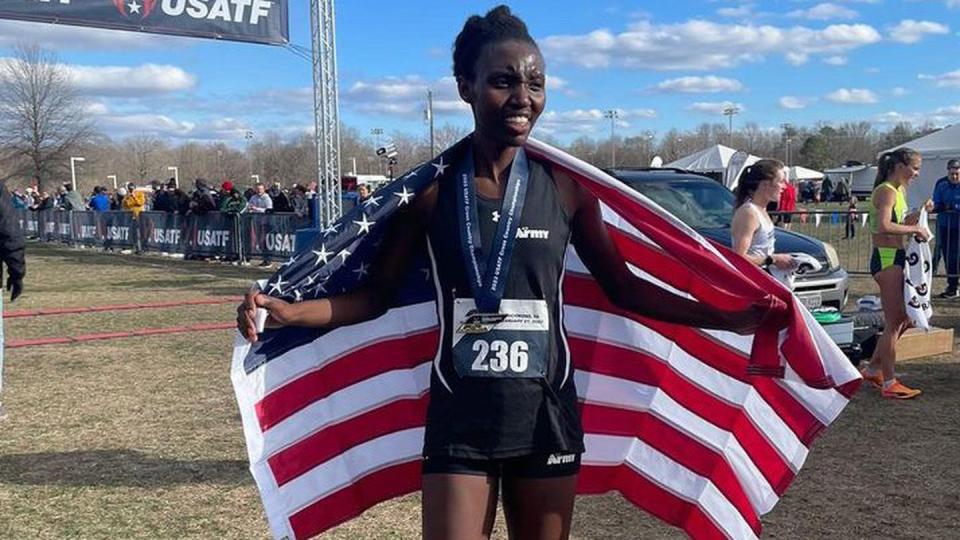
[{"left": 861, "top": 148, "right": 931, "bottom": 399}]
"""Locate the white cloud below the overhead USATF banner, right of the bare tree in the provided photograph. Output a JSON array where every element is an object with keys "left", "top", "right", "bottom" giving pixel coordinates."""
[{"left": 62, "top": 64, "right": 197, "bottom": 97}]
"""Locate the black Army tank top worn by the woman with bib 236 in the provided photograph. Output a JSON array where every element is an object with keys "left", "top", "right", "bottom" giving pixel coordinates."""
[{"left": 424, "top": 152, "right": 583, "bottom": 459}]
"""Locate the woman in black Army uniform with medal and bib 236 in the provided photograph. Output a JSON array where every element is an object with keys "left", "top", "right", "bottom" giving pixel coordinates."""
[{"left": 238, "top": 6, "right": 766, "bottom": 540}]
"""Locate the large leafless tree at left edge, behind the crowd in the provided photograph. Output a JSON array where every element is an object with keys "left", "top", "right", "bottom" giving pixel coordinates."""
[{"left": 0, "top": 46, "right": 92, "bottom": 189}]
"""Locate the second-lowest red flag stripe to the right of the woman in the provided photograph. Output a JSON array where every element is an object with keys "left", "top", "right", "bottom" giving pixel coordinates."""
[{"left": 582, "top": 403, "right": 760, "bottom": 534}]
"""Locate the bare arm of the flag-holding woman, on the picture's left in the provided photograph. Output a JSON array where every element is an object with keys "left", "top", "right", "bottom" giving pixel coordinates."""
[{"left": 237, "top": 184, "right": 437, "bottom": 343}]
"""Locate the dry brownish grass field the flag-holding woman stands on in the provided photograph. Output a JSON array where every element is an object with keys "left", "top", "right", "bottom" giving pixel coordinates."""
[{"left": 0, "top": 244, "right": 960, "bottom": 539}]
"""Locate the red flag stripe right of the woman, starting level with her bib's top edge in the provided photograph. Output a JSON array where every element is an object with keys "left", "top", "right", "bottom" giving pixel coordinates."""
[{"left": 563, "top": 274, "right": 824, "bottom": 446}]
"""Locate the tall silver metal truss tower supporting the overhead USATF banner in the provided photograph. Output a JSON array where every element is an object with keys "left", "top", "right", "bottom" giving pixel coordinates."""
[{"left": 310, "top": 0, "right": 341, "bottom": 227}]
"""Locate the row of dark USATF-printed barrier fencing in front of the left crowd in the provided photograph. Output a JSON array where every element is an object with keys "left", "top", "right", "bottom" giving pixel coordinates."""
[{"left": 17, "top": 209, "right": 310, "bottom": 259}]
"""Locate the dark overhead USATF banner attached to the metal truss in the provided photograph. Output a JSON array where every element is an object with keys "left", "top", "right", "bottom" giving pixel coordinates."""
[{"left": 0, "top": 0, "right": 290, "bottom": 45}]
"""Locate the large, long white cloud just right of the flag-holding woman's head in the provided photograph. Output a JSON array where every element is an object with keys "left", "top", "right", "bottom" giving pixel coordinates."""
[{"left": 540, "top": 20, "right": 881, "bottom": 70}]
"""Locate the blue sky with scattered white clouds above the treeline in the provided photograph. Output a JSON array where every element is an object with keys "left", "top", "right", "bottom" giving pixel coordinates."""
[{"left": 0, "top": 0, "right": 960, "bottom": 144}]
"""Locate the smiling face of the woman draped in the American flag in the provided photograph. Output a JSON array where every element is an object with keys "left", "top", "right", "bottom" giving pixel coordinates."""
[{"left": 457, "top": 40, "right": 547, "bottom": 147}]
